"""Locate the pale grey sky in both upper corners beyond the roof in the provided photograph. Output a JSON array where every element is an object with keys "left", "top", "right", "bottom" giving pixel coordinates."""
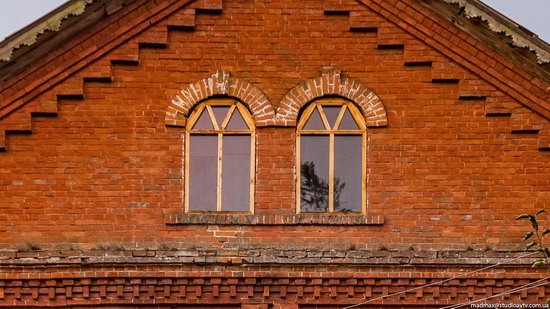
[{"left": 0, "top": 0, "right": 550, "bottom": 42}]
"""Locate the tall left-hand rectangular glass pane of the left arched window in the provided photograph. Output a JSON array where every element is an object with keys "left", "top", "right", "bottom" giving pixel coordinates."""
[{"left": 189, "top": 135, "right": 218, "bottom": 211}]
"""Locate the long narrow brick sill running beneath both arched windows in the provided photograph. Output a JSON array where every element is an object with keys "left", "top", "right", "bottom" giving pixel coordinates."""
[{"left": 164, "top": 212, "right": 384, "bottom": 225}]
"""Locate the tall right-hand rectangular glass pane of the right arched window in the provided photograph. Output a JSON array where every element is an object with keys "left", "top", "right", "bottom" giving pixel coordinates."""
[{"left": 334, "top": 135, "right": 363, "bottom": 212}]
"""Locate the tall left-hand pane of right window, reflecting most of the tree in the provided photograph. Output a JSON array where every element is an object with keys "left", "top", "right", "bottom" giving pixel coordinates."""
[{"left": 300, "top": 135, "right": 329, "bottom": 212}]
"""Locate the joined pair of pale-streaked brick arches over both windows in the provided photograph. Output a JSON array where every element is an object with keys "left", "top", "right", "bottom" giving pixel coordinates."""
[{"left": 165, "top": 70, "right": 388, "bottom": 127}]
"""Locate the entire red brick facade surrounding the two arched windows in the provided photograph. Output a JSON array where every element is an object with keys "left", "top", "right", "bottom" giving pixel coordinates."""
[{"left": 0, "top": 0, "right": 550, "bottom": 308}]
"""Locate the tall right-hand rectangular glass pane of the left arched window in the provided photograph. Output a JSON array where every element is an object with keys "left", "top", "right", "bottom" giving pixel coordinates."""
[{"left": 222, "top": 135, "right": 250, "bottom": 211}]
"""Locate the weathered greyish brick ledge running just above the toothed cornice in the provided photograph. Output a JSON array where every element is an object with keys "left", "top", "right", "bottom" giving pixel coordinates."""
[{"left": 0, "top": 244, "right": 531, "bottom": 266}]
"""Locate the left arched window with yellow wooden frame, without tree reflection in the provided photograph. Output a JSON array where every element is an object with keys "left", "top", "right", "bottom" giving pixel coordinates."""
[{"left": 185, "top": 99, "right": 255, "bottom": 212}]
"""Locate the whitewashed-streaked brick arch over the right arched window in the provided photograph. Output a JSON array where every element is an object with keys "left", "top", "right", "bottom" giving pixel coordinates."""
[{"left": 277, "top": 71, "right": 388, "bottom": 127}]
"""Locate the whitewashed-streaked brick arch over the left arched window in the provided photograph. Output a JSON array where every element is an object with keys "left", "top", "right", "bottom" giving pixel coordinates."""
[{"left": 165, "top": 70, "right": 275, "bottom": 127}]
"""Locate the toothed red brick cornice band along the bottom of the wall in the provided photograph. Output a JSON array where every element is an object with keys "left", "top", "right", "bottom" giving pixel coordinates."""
[{"left": 0, "top": 265, "right": 549, "bottom": 308}]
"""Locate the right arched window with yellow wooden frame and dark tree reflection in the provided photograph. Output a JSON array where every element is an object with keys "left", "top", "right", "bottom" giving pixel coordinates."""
[{"left": 296, "top": 98, "right": 366, "bottom": 213}]
